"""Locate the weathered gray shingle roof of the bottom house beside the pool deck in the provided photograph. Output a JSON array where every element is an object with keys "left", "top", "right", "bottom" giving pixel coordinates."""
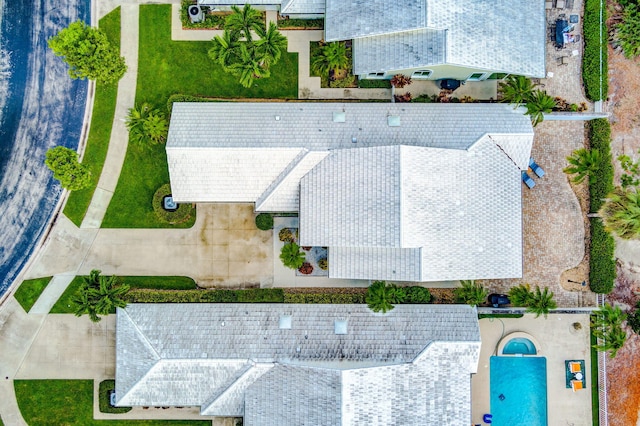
[{"left": 116, "top": 304, "right": 480, "bottom": 425}]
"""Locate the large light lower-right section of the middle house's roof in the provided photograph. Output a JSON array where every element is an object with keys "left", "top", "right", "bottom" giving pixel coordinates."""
[{"left": 300, "top": 137, "right": 522, "bottom": 281}]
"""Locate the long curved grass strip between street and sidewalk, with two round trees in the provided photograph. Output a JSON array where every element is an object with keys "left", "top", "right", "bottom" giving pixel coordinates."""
[{"left": 64, "top": 7, "right": 120, "bottom": 226}]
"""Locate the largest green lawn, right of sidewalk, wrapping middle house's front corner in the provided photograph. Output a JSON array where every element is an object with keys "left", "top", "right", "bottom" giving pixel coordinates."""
[{"left": 102, "top": 5, "right": 298, "bottom": 228}]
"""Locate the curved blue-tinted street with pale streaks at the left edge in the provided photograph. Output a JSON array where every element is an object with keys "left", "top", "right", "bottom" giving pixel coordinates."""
[{"left": 0, "top": 0, "right": 90, "bottom": 295}]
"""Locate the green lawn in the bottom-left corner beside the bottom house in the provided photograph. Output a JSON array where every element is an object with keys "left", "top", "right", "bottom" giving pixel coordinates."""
[{"left": 14, "top": 380, "right": 211, "bottom": 426}]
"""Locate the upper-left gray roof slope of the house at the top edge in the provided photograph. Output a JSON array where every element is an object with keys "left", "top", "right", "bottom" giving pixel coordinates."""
[{"left": 325, "top": 0, "right": 427, "bottom": 41}]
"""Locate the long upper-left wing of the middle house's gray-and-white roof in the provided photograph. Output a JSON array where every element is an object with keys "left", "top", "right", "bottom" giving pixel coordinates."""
[{"left": 166, "top": 102, "right": 533, "bottom": 205}]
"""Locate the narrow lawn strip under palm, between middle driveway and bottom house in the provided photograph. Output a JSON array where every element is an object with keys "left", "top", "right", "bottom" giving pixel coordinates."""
[{"left": 49, "top": 276, "right": 197, "bottom": 314}]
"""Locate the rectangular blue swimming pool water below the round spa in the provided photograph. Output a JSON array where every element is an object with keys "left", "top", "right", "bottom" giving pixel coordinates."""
[{"left": 489, "top": 356, "right": 547, "bottom": 426}]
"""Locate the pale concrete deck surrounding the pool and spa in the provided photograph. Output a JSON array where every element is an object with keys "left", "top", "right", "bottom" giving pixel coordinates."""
[{"left": 471, "top": 314, "right": 592, "bottom": 426}]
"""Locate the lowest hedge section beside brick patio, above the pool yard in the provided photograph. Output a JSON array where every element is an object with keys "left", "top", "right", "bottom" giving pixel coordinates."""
[{"left": 589, "top": 218, "right": 616, "bottom": 294}]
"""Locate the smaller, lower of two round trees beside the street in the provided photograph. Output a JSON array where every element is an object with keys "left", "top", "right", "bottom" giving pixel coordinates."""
[{"left": 44, "top": 146, "right": 91, "bottom": 191}]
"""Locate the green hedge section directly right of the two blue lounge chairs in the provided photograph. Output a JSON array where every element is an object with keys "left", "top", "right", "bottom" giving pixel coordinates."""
[{"left": 589, "top": 118, "right": 613, "bottom": 213}]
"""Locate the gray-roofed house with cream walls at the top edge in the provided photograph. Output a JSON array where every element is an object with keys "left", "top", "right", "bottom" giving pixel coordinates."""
[{"left": 198, "top": 0, "right": 546, "bottom": 82}]
